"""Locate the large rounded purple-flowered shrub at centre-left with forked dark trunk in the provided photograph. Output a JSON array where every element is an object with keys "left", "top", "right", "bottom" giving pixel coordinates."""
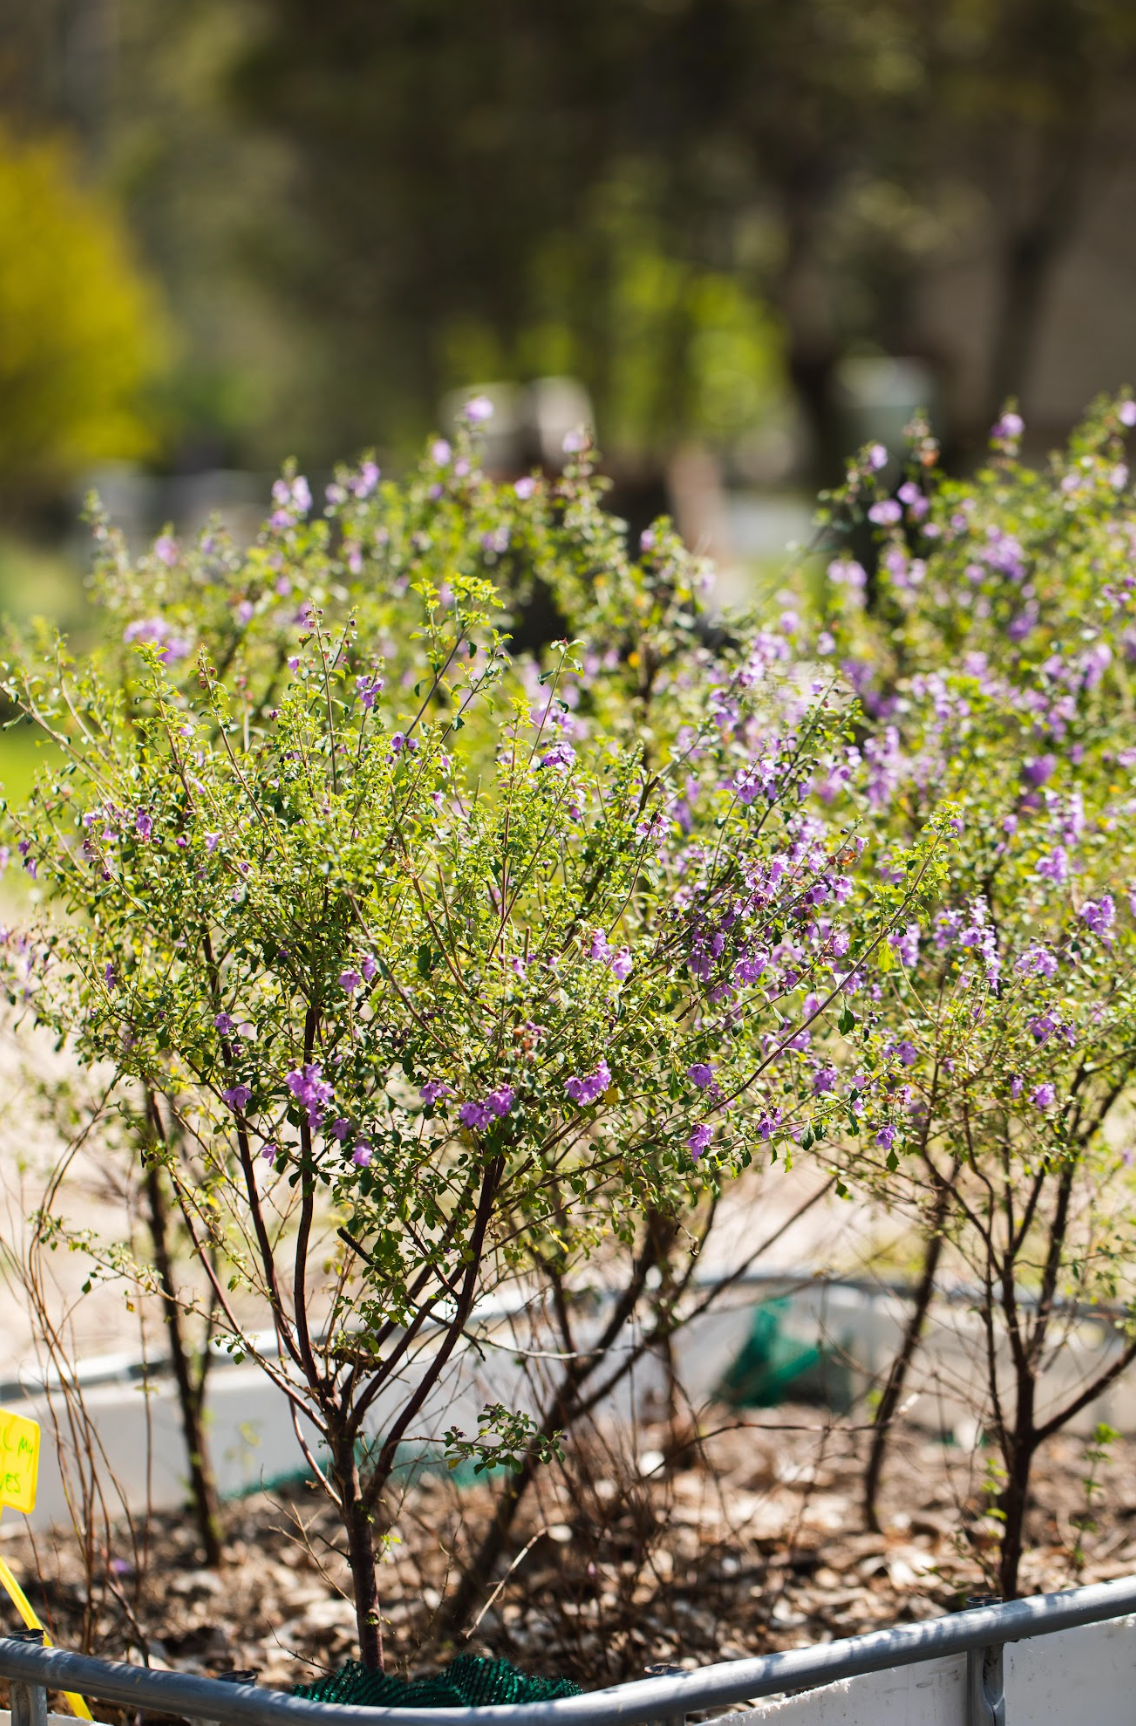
[{"left": 7, "top": 414, "right": 944, "bottom": 1662}]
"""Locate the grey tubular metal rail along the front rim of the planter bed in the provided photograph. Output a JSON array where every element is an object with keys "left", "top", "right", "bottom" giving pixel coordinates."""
[{"left": 0, "top": 1576, "right": 1136, "bottom": 1726}]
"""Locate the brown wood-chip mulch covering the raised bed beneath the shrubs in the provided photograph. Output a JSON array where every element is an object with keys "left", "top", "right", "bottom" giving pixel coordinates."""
[{"left": 0, "top": 1408, "right": 1136, "bottom": 1719}]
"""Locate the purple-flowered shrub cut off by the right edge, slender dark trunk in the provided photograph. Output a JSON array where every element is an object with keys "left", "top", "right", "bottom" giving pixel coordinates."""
[{"left": 822, "top": 400, "right": 1136, "bottom": 1595}]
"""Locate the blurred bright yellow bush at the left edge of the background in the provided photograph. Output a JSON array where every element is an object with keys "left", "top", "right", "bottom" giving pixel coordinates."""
[{"left": 0, "top": 133, "right": 162, "bottom": 511}]
